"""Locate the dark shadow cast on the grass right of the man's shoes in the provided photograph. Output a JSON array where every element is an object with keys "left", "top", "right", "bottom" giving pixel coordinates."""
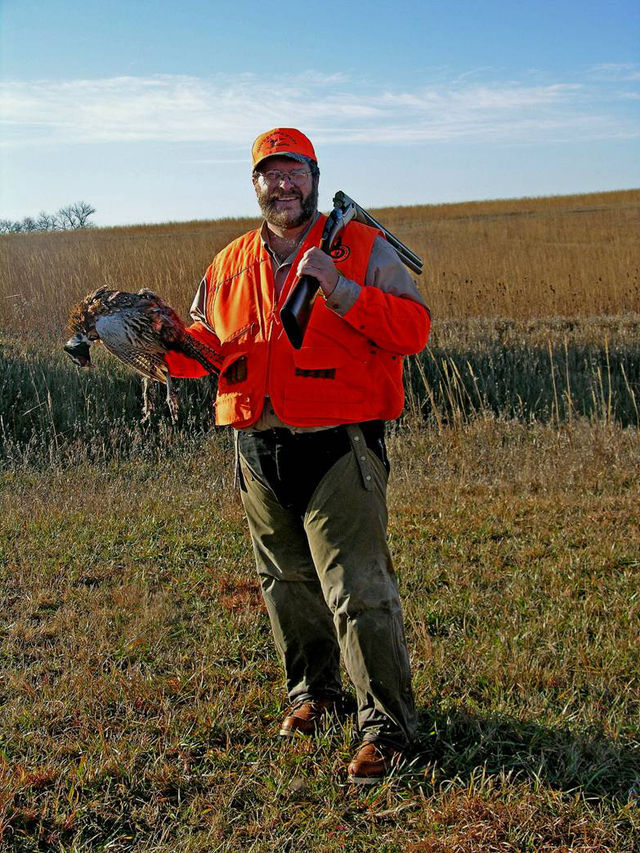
[{"left": 415, "top": 709, "right": 640, "bottom": 803}]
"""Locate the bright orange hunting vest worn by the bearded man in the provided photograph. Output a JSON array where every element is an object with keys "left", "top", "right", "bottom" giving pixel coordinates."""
[{"left": 206, "top": 215, "right": 418, "bottom": 429}]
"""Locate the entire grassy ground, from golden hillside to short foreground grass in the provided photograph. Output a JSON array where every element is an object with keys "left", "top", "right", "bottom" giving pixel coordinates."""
[{"left": 0, "top": 191, "right": 640, "bottom": 853}]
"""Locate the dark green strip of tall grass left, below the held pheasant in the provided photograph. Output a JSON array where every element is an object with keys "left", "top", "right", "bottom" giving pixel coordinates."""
[{"left": 0, "top": 332, "right": 215, "bottom": 466}]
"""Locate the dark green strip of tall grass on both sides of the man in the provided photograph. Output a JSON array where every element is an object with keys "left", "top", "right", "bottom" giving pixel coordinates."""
[{"left": 0, "top": 315, "right": 640, "bottom": 465}]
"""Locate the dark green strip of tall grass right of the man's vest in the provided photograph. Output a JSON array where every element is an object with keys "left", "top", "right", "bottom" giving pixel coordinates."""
[{"left": 406, "top": 315, "right": 640, "bottom": 427}]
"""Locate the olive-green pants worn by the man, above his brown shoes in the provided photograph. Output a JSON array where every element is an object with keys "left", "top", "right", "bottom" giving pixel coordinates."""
[{"left": 239, "top": 425, "right": 416, "bottom": 744}]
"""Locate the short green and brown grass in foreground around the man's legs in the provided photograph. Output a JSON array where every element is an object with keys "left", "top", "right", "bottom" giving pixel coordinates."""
[{"left": 0, "top": 418, "right": 640, "bottom": 853}]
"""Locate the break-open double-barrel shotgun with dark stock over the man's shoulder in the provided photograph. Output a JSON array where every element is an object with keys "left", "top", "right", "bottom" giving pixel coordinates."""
[{"left": 280, "top": 190, "right": 422, "bottom": 349}]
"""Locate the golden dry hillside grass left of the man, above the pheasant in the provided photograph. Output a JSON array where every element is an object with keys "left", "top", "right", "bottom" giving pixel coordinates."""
[{"left": 0, "top": 219, "right": 255, "bottom": 342}]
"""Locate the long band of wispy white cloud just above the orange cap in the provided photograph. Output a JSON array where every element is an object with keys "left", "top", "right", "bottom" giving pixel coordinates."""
[{"left": 0, "top": 64, "right": 638, "bottom": 148}]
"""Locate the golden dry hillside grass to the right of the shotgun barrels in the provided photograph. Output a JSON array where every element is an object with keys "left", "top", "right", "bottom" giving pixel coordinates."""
[{"left": 380, "top": 190, "right": 640, "bottom": 319}]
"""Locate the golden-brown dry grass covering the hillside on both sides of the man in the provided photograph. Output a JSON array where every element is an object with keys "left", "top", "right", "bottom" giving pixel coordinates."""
[{"left": 0, "top": 190, "right": 640, "bottom": 339}]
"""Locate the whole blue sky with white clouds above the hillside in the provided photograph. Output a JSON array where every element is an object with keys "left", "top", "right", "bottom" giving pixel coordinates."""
[{"left": 0, "top": 0, "right": 640, "bottom": 225}]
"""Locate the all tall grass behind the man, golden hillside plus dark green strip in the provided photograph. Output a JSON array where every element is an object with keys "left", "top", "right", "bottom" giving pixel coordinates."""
[{"left": 0, "top": 190, "right": 640, "bottom": 464}]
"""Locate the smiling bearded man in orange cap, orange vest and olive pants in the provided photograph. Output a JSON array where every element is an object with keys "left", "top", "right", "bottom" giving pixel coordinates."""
[{"left": 171, "top": 128, "right": 429, "bottom": 784}]
